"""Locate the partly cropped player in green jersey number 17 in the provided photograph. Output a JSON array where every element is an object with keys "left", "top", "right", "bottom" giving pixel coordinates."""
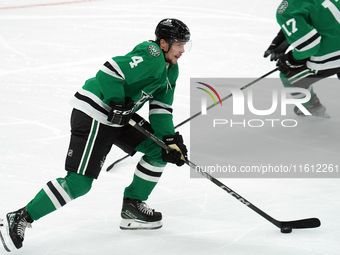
[{"left": 264, "top": 0, "right": 340, "bottom": 117}]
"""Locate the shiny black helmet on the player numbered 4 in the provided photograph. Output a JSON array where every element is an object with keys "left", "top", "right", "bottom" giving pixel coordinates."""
[{"left": 155, "top": 19, "right": 190, "bottom": 47}]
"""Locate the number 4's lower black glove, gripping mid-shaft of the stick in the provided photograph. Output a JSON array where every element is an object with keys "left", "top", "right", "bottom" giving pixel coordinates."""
[{"left": 162, "top": 132, "right": 188, "bottom": 166}]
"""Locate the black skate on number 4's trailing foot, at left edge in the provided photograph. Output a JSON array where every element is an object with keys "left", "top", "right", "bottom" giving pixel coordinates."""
[{"left": 0, "top": 207, "right": 33, "bottom": 252}]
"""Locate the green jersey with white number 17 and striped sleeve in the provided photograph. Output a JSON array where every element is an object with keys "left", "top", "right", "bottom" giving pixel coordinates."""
[{"left": 276, "top": 0, "right": 340, "bottom": 70}]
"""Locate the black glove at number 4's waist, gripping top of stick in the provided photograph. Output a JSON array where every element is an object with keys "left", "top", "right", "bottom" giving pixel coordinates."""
[{"left": 107, "top": 97, "right": 135, "bottom": 126}]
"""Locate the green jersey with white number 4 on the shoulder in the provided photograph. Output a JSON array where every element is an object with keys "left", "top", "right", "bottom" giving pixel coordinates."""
[{"left": 71, "top": 41, "right": 178, "bottom": 138}]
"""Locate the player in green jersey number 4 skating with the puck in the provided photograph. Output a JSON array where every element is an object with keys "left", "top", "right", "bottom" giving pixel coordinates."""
[{"left": 0, "top": 19, "right": 190, "bottom": 251}]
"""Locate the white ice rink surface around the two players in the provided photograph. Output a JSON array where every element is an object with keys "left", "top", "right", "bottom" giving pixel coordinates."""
[{"left": 0, "top": 0, "right": 340, "bottom": 255}]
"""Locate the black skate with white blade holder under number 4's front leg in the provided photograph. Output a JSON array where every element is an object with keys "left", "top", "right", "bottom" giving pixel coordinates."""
[{"left": 120, "top": 197, "right": 163, "bottom": 230}]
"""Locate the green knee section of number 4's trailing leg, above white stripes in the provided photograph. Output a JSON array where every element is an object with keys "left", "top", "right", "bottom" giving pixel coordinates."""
[{"left": 57, "top": 172, "right": 94, "bottom": 199}]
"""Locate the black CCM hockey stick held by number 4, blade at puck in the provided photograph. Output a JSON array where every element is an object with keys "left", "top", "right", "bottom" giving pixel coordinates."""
[{"left": 129, "top": 120, "right": 321, "bottom": 233}]
